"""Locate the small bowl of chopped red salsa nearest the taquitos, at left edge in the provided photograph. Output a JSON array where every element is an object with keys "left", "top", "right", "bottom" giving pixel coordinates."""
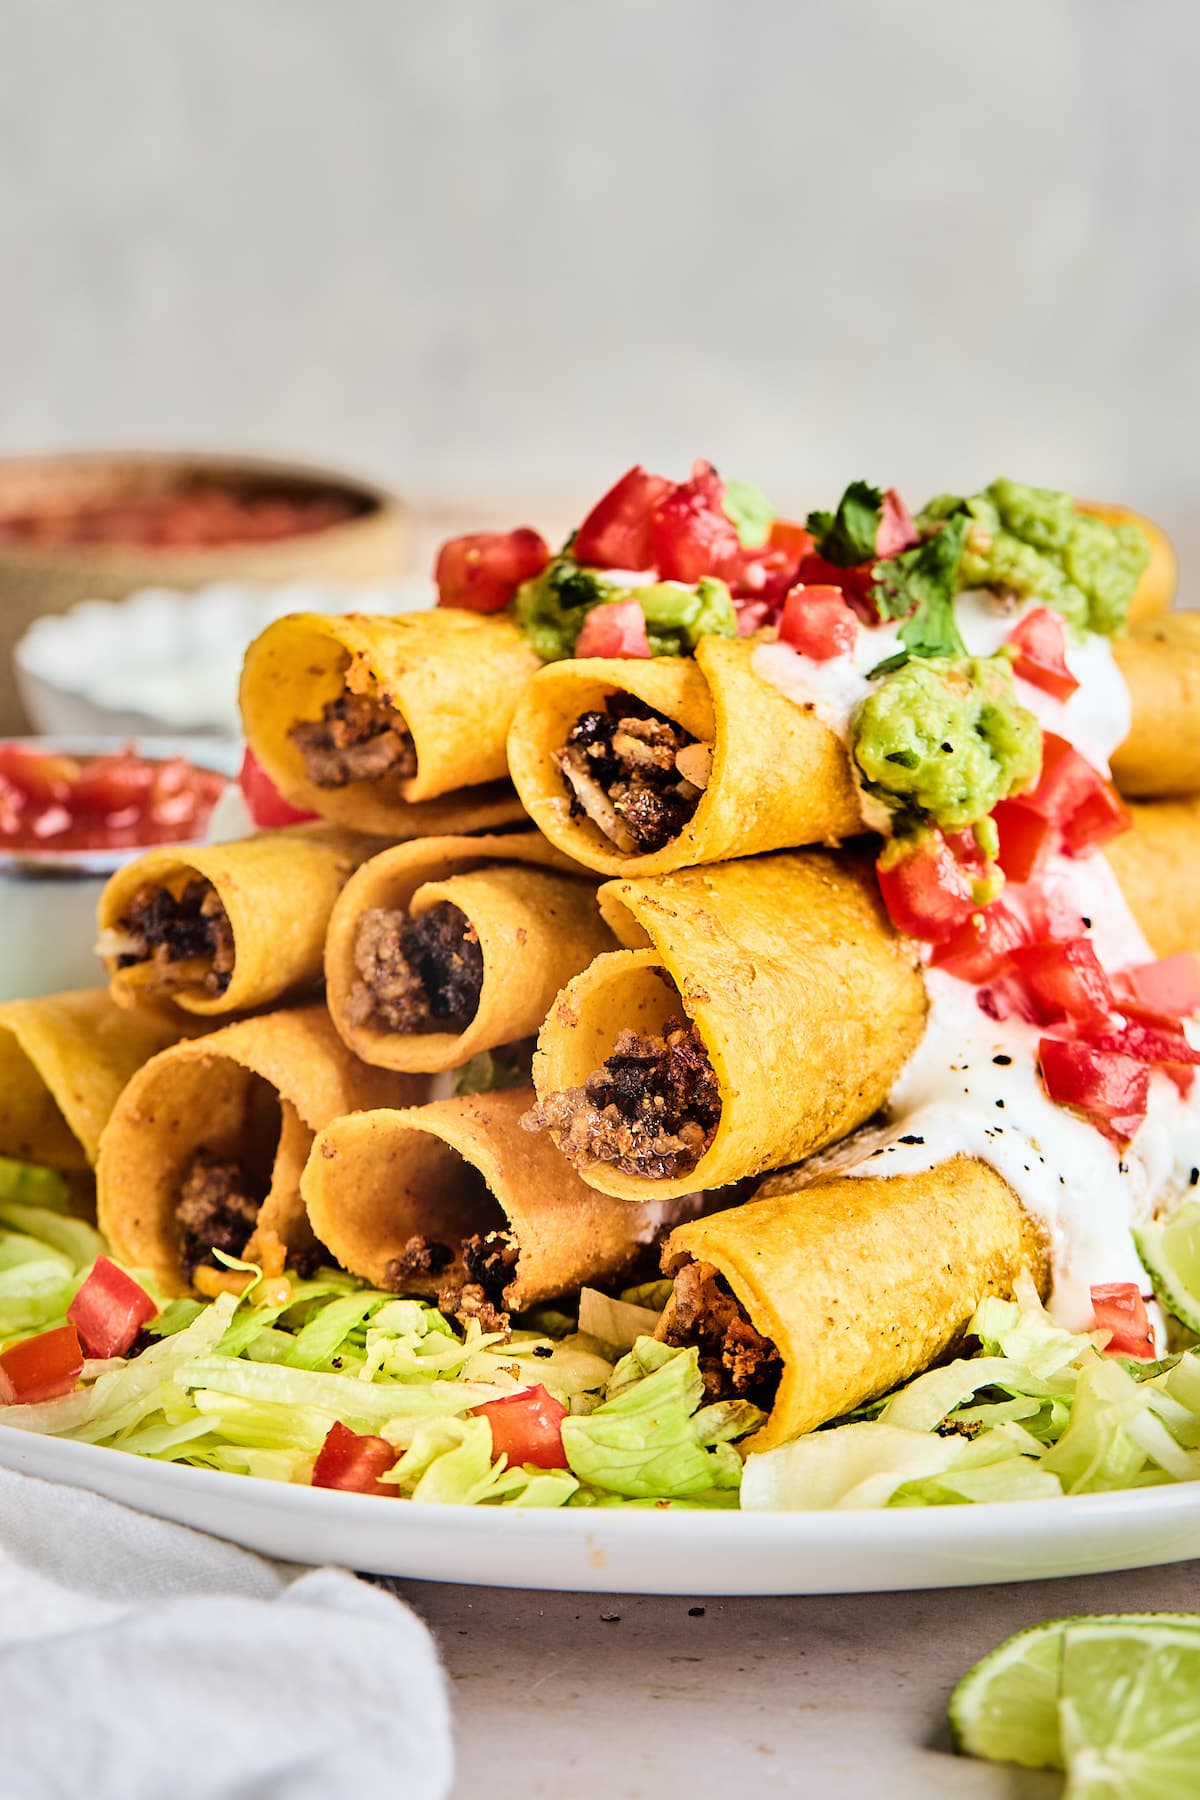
[{"left": 0, "top": 738, "right": 237, "bottom": 999}]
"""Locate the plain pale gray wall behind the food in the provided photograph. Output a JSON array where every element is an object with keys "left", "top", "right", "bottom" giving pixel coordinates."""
[{"left": 0, "top": 0, "right": 1200, "bottom": 549}]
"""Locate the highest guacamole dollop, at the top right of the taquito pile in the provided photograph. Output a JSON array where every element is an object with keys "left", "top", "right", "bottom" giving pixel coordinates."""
[{"left": 918, "top": 479, "right": 1150, "bottom": 637}]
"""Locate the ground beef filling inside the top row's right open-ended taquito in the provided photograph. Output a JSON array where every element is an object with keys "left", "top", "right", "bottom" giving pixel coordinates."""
[{"left": 554, "top": 693, "right": 712, "bottom": 855}]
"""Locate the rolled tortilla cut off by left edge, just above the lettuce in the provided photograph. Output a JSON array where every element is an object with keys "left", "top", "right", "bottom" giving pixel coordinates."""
[{"left": 0, "top": 988, "right": 184, "bottom": 1174}]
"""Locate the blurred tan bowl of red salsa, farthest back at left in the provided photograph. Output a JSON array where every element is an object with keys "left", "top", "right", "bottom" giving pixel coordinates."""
[{"left": 0, "top": 452, "right": 408, "bottom": 731}]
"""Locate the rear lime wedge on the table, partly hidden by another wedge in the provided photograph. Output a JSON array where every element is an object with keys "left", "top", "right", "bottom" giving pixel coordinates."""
[{"left": 950, "top": 1613, "right": 1200, "bottom": 1771}]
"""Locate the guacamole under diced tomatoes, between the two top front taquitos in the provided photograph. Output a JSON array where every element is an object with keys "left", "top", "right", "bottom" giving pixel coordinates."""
[{"left": 516, "top": 556, "right": 738, "bottom": 662}]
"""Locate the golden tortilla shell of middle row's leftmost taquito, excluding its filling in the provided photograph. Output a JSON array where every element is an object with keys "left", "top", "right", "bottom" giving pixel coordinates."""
[{"left": 97, "top": 824, "right": 380, "bottom": 1017}]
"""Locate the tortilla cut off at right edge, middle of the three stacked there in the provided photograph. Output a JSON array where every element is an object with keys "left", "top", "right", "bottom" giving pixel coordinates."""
[{"left": 1112, "top": 612, "right": 1200, "bottom": 797}]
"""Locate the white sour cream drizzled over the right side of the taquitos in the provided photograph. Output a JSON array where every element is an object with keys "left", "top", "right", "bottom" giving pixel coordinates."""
[{"left": 754, "top": 594, "right": 1200, "bottom": 1330}]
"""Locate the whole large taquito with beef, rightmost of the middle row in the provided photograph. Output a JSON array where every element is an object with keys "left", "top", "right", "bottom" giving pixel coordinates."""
[{"left": 531, "top": 851, "right": 927, "bottom": 1201}]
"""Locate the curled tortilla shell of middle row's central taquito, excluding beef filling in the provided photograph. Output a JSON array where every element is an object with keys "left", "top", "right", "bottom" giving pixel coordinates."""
[{"left": 326, "top": 832, "right": 613, "bottom": 1071}]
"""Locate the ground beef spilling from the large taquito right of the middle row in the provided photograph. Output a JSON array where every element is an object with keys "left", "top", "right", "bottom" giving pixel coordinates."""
[{"left": 524, "top": 1019, "right": 721, "bottom": 1179}]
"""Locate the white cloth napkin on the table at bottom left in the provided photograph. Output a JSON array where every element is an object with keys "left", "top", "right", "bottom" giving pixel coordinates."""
[{"left": 0, "top": 1469, "right": 452, "bottom": 1800}]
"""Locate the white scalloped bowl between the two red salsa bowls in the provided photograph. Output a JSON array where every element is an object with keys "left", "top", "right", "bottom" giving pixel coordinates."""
[{"left": 14, "top": 581, "right": 434, "bottom": 738}]
